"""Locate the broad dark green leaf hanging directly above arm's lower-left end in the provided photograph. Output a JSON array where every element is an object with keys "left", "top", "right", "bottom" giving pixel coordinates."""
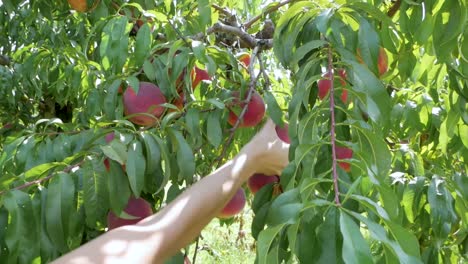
[{"left": 45, "top": 172, "right": 75, "bottom": 253}]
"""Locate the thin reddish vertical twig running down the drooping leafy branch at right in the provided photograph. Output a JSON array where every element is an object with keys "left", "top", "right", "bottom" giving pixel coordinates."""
[{"left": 327, "top": 44, "right": 341, "bottom": 206}]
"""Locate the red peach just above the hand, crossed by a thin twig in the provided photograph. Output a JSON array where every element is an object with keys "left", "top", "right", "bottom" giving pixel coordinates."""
[{"left": 228, "top": 91, "right": 265, "bottom": 127}]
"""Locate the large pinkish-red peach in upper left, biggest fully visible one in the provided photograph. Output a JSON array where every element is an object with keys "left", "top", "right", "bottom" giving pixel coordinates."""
[{"left": 123, "top": 82, "right": 166, "bottom": 126}]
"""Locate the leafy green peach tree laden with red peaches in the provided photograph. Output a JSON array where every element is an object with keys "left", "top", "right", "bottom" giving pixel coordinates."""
[{"left": 0, "top": 0, "right": 468, "bottom": 264}]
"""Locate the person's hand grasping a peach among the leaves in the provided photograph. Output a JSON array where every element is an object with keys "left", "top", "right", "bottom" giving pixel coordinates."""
[{"left": 241, "top": 119, "right": 289, "bottom": 175}]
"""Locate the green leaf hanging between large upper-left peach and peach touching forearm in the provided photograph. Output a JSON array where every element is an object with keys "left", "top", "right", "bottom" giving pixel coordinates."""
[{"left": 125, "top": 140, "right": 146, "bottom": 197}]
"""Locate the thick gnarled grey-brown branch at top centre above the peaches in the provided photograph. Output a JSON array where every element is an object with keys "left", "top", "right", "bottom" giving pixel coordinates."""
[{"left": 193, "top": 22, "right": 273, "bottom": 50}]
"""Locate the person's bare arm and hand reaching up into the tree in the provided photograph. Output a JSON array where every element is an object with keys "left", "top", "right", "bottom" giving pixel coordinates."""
[{"left": 53, "top": 120, "right": 289, "bottom": 264}]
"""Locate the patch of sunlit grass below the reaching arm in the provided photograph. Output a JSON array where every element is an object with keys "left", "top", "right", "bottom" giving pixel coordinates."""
[{"left": 189, "top": 205, "right": 255, "bottom": 264}]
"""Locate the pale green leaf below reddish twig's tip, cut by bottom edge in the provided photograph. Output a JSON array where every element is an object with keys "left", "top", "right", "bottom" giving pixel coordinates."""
[{"left": 340, "top": 212, "right": 374, "bottom": 263}]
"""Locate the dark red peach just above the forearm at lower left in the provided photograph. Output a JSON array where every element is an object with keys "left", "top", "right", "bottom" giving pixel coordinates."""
[{"left": 107, "top": 197, "right": 153, "bottom": 230}]
